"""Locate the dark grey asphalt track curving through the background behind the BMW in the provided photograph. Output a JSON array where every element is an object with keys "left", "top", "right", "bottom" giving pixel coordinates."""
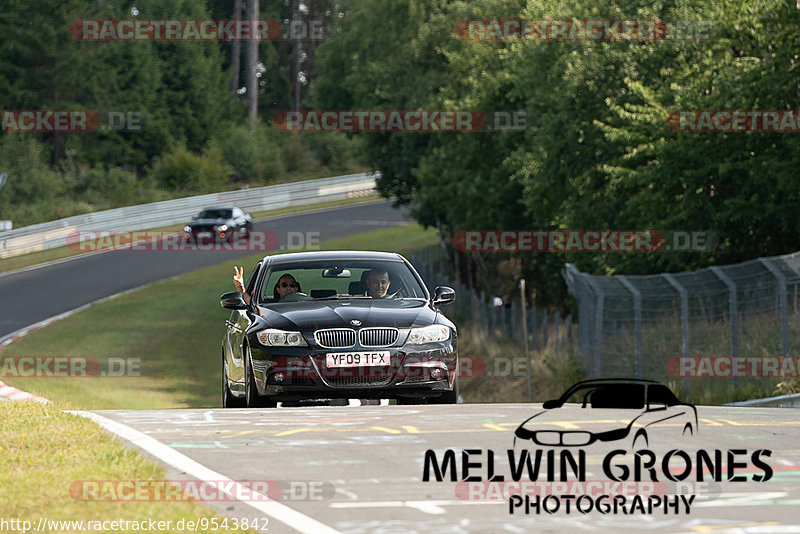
[{"left": 0, "top": 201, "right": 409, "bottom": 339}]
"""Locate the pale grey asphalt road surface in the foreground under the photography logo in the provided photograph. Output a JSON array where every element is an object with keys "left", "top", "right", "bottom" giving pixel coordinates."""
[{"left": 87, "top": 404, "right": 800, "bottom": 534}]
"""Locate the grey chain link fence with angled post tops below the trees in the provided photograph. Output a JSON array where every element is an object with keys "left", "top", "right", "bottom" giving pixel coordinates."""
[{"left": 562, "top": 252, "right": 800, "bottom": 387}]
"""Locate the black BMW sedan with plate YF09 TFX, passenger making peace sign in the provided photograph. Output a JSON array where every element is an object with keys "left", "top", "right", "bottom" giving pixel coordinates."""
[{"left": 220, "top": 252, "right": 458, "bottom": 407}]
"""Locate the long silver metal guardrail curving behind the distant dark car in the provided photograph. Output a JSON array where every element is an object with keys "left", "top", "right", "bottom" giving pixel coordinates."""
[{"left": 0, "top": 173, "right": 378, "bottom": 258}]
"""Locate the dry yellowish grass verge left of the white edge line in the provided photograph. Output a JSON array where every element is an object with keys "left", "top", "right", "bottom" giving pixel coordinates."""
[{"left": 0, "top": 402, "right": 250, "bottom": 532}]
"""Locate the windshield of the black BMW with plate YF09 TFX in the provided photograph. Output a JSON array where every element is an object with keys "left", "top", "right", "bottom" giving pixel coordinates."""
[{"left": 260, "top": 259, "right": 425, "bottom": 303}]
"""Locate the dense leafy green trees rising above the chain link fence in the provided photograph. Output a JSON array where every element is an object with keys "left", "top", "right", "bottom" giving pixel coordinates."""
[{"left": 315, "top": 0, "right": 800, "bottom": 310}]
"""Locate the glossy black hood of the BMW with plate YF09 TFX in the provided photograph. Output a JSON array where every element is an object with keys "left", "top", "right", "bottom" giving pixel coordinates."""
[{"left": 259, "top": 299, "right": 437, "bottom": 331}]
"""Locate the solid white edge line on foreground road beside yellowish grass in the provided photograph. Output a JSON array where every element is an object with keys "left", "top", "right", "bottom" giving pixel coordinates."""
[{"left": 76, "top": 410, "right": 340, "bottom": 534}]
